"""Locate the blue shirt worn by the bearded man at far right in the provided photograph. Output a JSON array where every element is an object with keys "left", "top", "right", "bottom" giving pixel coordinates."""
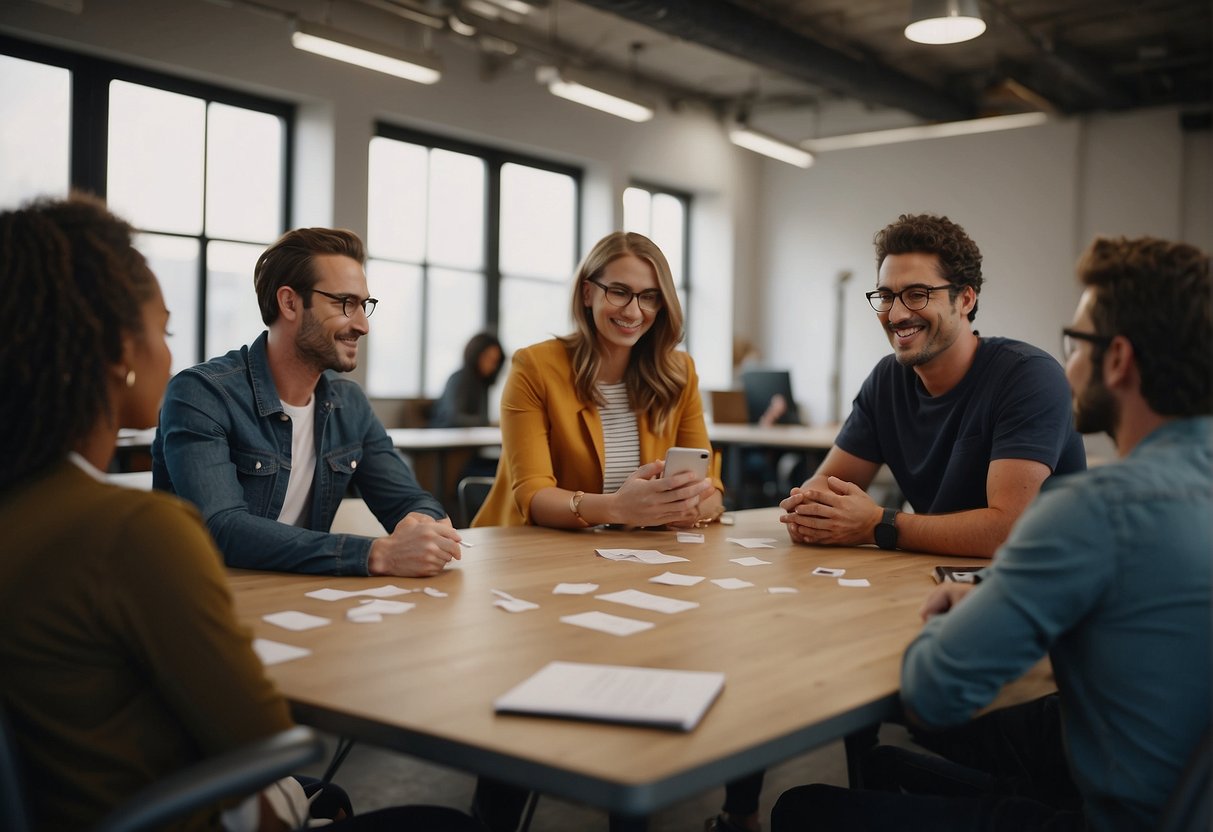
[{"left": 901, "top": 417, "right": 1213, "bottom": 830}]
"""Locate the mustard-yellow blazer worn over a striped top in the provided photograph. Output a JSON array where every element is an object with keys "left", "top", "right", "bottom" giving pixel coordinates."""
[{"left": 472, "top": 338, "right": 724, "bottom": 526}]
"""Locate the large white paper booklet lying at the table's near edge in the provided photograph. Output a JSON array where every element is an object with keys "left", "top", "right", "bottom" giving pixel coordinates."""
[{"left": 492, "top": 661, "right": 724, "bottom": 731}]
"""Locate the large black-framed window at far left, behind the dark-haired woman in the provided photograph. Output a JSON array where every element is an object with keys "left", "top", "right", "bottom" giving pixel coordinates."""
[{"left": 0, "top": 38, "right": 294, "bottom": 371}]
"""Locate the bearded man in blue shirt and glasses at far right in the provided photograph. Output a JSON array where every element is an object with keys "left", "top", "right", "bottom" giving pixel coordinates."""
[{"left": 771, "top": 238, "right": 1213, "bottom": 832}]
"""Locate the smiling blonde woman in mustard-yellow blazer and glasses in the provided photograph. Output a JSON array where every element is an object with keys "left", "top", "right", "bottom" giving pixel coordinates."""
[{"left": 472, "top": 232, "right": 723, "bottom": 529}]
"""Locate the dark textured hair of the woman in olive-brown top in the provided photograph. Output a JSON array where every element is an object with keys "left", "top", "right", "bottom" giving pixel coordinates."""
[{"left": 0, "top": 194, "right": 156, "bottom": 489}]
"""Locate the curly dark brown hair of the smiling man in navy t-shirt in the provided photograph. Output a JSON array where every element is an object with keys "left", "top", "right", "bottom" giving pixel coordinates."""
[{"left": 872, "top": 213, "right": 985, "bottom": 321}]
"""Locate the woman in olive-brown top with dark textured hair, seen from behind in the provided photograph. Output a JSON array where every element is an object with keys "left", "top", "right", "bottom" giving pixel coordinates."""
[{"left": 0, "top": 195, "right": 478, "bottom": 831}]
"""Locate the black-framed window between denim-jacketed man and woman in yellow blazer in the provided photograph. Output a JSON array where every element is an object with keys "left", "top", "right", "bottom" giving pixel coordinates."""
[{"left": 366, "top": 125, "right": 580, "bottom": 397}]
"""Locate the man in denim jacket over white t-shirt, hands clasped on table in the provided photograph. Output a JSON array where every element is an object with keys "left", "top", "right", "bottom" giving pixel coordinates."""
[{"left": 152, "top": 228, "right": 460, "bottom": 577}]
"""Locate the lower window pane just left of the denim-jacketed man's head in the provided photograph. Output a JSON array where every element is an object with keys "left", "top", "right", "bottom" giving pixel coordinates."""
[{"left": 206, "top": 243, "right": 266, "bottom": 358}]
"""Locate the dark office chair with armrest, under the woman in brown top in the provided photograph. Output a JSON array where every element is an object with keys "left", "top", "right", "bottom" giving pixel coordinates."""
[{"left": 0, "top": 707, "right": 324, "bottom": 832}]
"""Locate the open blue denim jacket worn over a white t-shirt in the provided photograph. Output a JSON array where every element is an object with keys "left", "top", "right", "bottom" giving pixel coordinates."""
[{"left": 152, "top": 332, "right": 446, "bottom": 575}]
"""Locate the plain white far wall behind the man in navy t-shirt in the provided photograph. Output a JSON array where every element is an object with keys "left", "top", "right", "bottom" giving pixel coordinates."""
[{"left": 758, "top": 109, "right": 1213, "bottom": 446}]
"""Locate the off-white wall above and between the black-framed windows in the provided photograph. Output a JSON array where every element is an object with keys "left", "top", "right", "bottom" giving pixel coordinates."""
[{"left": 0, "top": 0, "right": 759, "bottom": 387}]
